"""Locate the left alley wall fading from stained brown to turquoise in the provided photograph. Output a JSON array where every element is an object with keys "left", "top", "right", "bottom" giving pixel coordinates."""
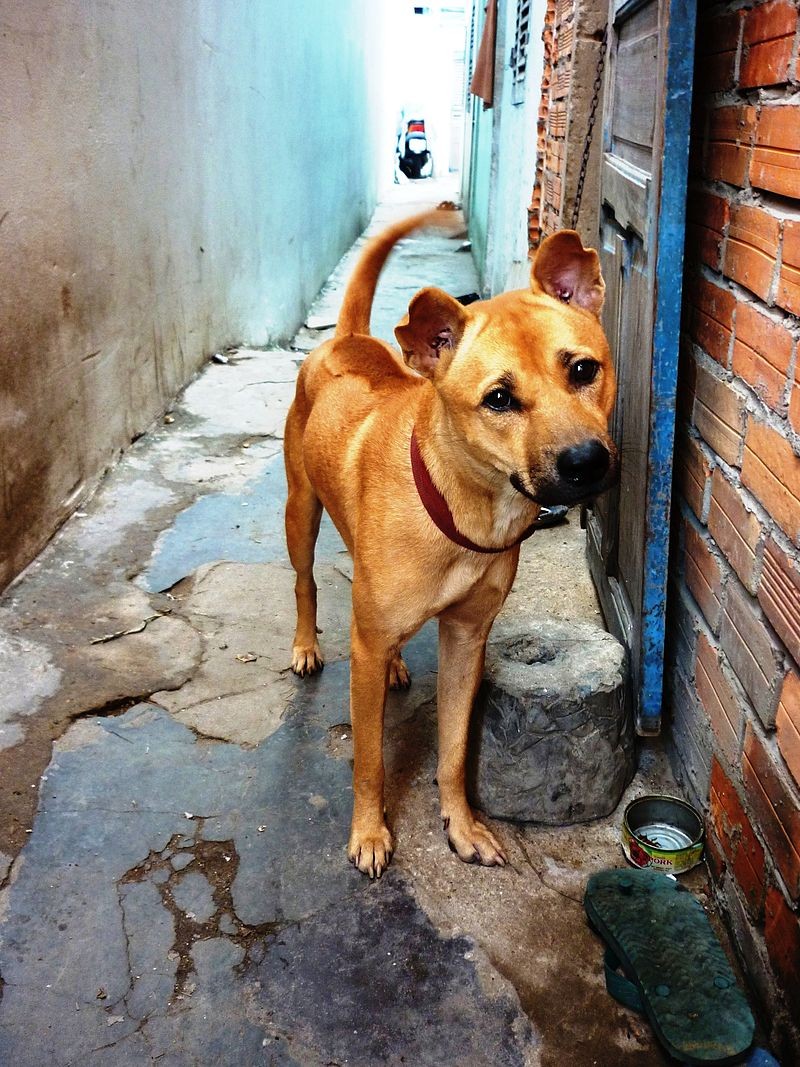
[{"left": 0, "top": 0, "right": 382, "bottom": 587}]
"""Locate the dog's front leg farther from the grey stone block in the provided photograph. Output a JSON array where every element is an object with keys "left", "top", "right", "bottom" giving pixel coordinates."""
[{"left": 348, "top": 620, "right": 395, "bottom": 878}]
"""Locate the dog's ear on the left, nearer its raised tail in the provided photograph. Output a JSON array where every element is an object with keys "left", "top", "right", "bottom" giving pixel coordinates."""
[{"left": 395, "top": 288, "right": 468, "bottom": 378}]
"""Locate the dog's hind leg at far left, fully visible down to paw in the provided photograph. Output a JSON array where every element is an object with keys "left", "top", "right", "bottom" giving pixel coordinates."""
[{"left": 284, "top": 405, "right": 324, "bottom": 678}]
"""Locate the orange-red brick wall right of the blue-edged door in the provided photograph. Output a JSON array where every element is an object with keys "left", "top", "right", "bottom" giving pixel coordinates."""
[{"left": 668, "top": 0, "right": 800, "bottom": 1062}]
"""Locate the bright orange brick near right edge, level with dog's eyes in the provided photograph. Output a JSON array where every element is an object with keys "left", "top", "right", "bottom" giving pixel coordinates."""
[{"left": 733, "top": 304, "right": 794, "bottom": 411}]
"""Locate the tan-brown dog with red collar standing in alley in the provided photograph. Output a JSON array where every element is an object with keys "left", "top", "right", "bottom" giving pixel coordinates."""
[{"left": 285, "top": 212, "right": 615, "bottom": 877}]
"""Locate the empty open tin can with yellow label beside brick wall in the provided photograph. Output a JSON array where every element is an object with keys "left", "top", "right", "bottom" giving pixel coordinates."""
[{"left": 622, "top": 796, "right": 705, "bottom": 874}]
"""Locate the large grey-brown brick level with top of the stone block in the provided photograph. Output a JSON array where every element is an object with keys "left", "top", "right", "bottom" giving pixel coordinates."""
[{"left": 720, "top": 580, "right": 786, "bottom": 728}]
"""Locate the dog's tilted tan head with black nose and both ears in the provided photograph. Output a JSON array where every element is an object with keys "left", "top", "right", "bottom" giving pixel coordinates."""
[{"left": 395, "top": 230, "right": 617, "bottom": 504}]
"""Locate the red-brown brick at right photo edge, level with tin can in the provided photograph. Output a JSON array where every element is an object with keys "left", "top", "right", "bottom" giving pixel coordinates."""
[{"left": 741, "top": 723, "right": 800, "bottom": 901}]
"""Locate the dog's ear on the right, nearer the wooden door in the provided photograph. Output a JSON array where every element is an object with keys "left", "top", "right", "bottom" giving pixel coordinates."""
[{"left": 530, "top": 229, "right": 606, "bottom": 318}]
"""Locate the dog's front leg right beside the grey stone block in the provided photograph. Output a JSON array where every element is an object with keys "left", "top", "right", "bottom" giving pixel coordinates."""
[{"left": 436, "top": 609, "right": 506, "bottom": 866}]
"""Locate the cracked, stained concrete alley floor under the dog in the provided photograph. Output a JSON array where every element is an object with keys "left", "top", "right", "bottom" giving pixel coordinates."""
[{"left": 0, "top": 184, "right": 725, "bottom": 1067}]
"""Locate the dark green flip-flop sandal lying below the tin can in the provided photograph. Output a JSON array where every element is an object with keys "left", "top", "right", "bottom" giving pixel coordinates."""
[{"left": 583, "top": 870, "right": 755, "bottom": 1064}]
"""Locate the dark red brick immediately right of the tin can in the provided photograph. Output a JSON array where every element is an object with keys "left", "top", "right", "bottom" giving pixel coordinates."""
[{"left": 710, "top": 760, "right": 766, "bottom": 918}]
